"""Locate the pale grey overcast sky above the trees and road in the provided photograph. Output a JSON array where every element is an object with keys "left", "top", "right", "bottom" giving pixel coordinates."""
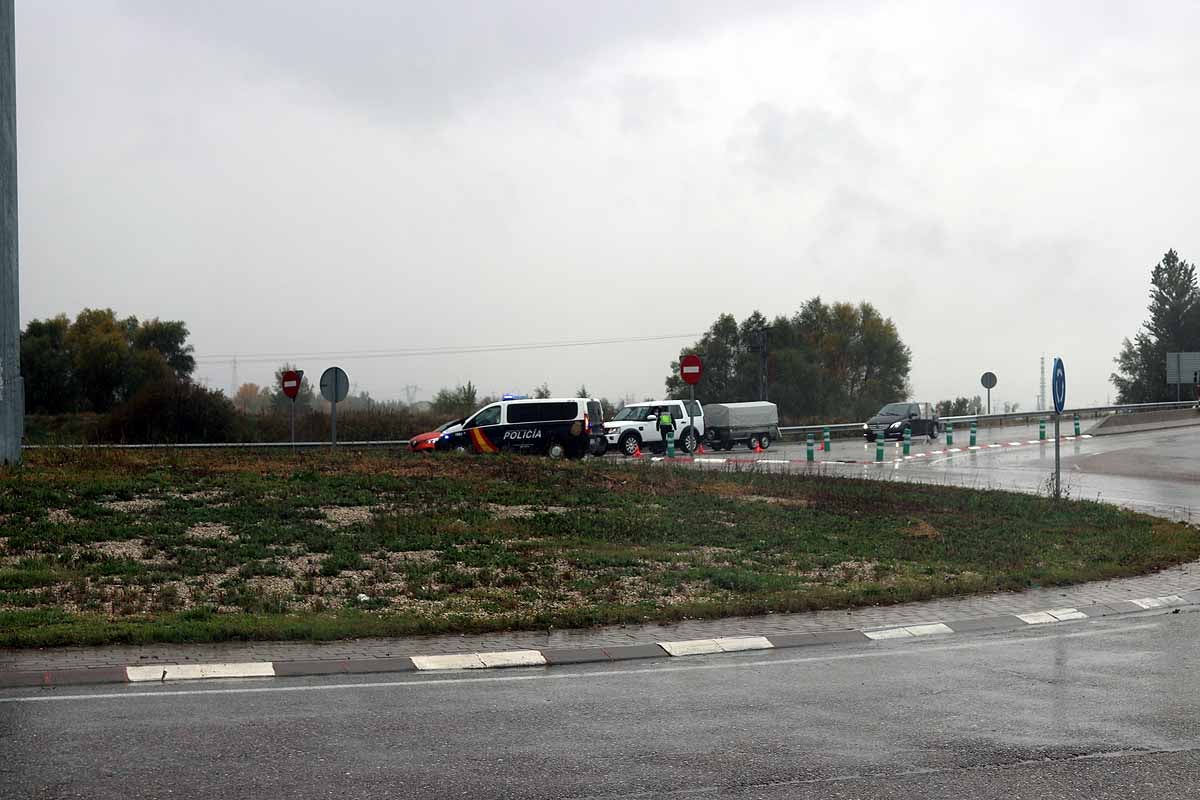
[{"left": 17, "top": 0, "right": 1200, "bottom": 408}]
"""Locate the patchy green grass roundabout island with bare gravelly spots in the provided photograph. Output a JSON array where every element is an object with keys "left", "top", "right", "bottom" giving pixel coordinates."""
[{"left": 0, "top": 450, "right": 1200, "bottom": 646}]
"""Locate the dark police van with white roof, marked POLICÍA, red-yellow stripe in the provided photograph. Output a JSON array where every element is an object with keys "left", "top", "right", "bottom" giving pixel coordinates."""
[{"left": 437, "top": 397, "right": 604, "bottom": 458}]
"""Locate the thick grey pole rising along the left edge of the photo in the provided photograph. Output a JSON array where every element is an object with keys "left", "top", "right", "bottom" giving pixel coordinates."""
[{"left": 0, "top": 0, "right": 25, "bottom": 464}]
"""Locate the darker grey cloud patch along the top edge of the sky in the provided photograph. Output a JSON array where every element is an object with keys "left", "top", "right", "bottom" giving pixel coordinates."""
[{"left": 125, "top": 0, "right": 794, "bottom": 122}]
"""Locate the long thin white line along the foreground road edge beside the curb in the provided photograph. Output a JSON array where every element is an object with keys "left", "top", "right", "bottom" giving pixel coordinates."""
[{"left": 0, "top": 622, "right": 1163, "bottom": 704}]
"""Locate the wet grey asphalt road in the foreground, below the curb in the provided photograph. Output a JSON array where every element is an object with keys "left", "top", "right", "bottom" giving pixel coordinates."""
[{"left": 0, "top": 613, "right": 1200, "bottom": 800}]
